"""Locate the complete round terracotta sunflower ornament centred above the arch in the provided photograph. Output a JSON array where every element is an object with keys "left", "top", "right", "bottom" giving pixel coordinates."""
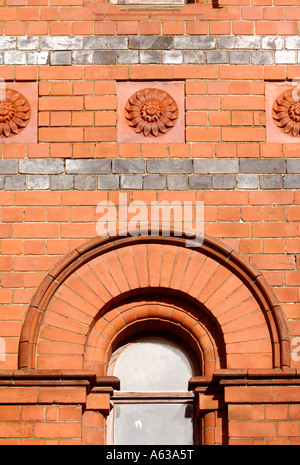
[{"left": 125, "top": 89, "right": 178, "bottom": 137}]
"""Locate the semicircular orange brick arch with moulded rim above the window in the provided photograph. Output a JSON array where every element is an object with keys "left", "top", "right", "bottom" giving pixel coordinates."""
[{"left": 19, "top": 233, "right": 290, "bottom": 373}]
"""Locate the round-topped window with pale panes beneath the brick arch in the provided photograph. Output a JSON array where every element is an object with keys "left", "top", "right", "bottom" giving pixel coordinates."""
[{"left": 108, "top": 337, "right": 199, "bottom": 445}]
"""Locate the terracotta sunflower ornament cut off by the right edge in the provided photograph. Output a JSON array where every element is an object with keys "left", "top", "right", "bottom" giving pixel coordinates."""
[{"left": 273, "top": 88, "right": 300, "bottom": 137}]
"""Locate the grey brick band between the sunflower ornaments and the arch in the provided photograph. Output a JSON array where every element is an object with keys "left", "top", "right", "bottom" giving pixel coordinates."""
[{"left": 0, "top": 158, "right": 300, "bottom": 191}]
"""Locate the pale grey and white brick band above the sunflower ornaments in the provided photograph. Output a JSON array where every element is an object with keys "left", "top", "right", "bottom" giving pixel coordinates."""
[{"left": 0, "top": 35, "right": 300, "bottom": 66}]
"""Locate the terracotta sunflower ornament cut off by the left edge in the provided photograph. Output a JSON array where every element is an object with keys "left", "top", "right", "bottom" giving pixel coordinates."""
[{"left": 0, "top": 89, "right": 30, "bottom": 138}]
